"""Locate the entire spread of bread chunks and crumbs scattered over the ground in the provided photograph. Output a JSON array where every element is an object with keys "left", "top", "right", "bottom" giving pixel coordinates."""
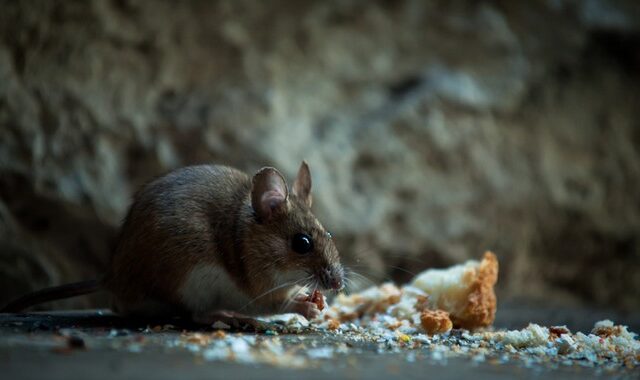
[{"left": 7, "top": 253, "right": 640, "bottom": 371}]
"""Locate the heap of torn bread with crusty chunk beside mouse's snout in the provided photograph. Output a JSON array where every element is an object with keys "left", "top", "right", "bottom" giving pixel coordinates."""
[{"left": 324, "top": 252, "right": 498, "bottom": 334}]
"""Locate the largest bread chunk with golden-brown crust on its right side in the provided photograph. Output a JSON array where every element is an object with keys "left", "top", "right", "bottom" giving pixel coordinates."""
[{"left": 412, "top": 252, "right": 498, "bottom": 329}]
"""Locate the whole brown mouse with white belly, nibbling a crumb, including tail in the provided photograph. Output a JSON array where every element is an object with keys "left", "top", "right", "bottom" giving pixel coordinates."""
[{"left": 1, "top": 161, "right": 345, "bottom": 325}]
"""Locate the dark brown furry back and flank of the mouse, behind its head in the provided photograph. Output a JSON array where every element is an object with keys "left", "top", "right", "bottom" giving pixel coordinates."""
[{"left": 105, "top": 165, "right": 251, "bottom": 309}]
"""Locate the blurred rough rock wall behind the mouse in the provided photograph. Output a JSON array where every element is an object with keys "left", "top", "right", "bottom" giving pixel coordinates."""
[{"left": 0, "top": 0, "right": 640, "bottom": 310}]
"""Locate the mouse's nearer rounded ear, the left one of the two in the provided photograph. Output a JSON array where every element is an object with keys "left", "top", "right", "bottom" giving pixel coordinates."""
[{"left": 251, "top": 167, "right": 289, "bottom": 221}]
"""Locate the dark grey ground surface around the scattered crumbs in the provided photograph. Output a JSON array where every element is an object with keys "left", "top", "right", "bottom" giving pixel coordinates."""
[{"left": 0, "top": 306, "right": 640, "bottom": 380}]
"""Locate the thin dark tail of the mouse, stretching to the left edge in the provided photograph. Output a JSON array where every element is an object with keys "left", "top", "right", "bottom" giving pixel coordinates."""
[{"left": 0, "top": 280, "right": 102, "bottom": 313}]
